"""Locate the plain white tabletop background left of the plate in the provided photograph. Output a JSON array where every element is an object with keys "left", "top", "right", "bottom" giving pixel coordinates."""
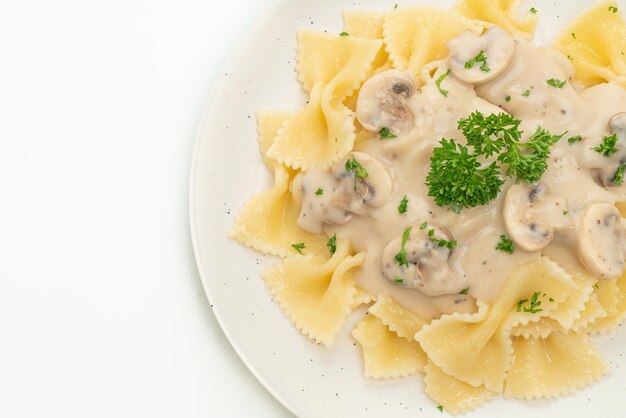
[{"left": 0, "top": 0, "right": 288, "bottom": 417}]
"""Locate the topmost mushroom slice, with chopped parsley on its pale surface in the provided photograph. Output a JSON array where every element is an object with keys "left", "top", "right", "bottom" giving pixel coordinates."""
[{"left": 448, "top": 26, "right": 515, "bottom": 84}]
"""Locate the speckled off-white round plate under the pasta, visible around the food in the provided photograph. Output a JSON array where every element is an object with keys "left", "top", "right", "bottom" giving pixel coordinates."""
[{"left": 190, "top": 0, "right": 626, "bottom": 418}]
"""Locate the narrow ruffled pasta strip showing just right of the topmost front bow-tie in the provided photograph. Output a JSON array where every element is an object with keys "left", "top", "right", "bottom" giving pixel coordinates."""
[{"left": 512, "top": 274, "right": 596, "bottom": 338}]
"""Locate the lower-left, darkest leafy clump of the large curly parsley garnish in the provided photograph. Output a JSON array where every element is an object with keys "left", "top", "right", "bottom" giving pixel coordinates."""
[{"left": 426, "top": 139, "right": 504, "bottom": 212}]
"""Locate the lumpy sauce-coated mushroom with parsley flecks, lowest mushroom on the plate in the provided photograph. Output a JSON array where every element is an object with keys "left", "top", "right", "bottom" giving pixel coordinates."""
[{"left": 382, "top": 223, "right": 465, "bottom": 296}]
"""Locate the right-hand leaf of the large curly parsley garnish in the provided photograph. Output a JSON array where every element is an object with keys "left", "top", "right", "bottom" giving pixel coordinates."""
[{"left": 498, "top": 128, "right": 563, "bottom": 184}]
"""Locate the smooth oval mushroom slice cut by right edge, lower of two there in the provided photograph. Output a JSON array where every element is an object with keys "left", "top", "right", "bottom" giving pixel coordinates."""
[{"left": 577, "top": 203, "right": 626, "bottom": 279}]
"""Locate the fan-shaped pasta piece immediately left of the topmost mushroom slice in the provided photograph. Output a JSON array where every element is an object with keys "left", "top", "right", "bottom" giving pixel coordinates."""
[{"left": 384, "top": 7, "right": 484, "bottom": 81}]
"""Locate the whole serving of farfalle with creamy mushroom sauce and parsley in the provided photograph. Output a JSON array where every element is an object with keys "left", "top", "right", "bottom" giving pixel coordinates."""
[{"left": 231, "top": 0, "right": 626, "bottom": 414}]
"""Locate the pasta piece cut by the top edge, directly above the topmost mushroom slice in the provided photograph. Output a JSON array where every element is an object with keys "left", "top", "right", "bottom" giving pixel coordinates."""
[{"left": 454, "top": 0, "right": 537, "bottom": 39}]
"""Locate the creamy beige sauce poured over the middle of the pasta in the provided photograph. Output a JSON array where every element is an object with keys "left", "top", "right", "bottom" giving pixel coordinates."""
[{"left": 299, "top": 29, "right": 626, "bottom": 318}]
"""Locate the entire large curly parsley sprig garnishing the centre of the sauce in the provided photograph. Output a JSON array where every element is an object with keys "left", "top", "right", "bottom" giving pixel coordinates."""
[{"left": 426, "top": 112, "right": 563, "bottom": 213}]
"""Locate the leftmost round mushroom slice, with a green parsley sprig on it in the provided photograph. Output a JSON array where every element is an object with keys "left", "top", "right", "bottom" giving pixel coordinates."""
[{"left": 332, "top": 152, "right": 393, "bottom": 215}]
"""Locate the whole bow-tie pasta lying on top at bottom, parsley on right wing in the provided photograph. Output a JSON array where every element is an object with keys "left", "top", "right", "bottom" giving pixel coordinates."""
[{"left": 415, "top": 257, "right": 577, "bottom": 393}]
